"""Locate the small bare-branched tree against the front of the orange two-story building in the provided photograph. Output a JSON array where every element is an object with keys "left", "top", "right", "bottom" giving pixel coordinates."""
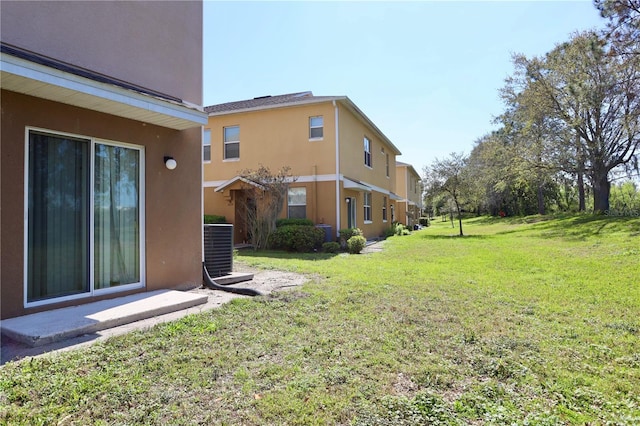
[{"left": 236, "top": 165, "right": 296, "bottom": 250}]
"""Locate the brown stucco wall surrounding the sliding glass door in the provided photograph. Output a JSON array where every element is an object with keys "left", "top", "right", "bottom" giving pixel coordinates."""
[{"left": 0, "top": 91, "right": 202, "bottom": 318}]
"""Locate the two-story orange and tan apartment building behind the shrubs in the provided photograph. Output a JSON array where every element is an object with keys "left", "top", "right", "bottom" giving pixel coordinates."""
[{"left": 203, "top": 92, "right": 400, "bottom": 243}]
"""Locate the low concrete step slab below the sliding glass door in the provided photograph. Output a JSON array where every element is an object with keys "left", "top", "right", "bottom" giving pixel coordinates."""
[{"left": 0, "top": 290, "right": 208, "bottom": 347}]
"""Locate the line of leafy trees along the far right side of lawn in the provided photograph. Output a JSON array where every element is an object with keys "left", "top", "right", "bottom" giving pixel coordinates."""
[{"left": 424, "top": 0, "right": 640, "bottom": 220}]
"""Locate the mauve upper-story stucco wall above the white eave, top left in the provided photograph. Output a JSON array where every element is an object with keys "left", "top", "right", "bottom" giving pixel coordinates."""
[{"left": 0, "top": 0, "right": 203, "bottom": 105}]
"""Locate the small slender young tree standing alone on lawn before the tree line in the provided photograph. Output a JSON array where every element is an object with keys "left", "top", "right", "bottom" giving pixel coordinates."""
[{"left": 424, "top": 153, "right": 469, "bottom": 237}]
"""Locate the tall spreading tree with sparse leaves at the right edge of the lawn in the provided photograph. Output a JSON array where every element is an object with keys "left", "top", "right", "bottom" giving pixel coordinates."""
[{"left": 515, "top": 32, "right": 640, "bottom": 213}]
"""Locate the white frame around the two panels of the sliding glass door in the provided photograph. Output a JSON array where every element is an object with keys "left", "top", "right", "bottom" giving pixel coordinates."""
[{"left": 22, "top": 127, "right": 147, "bottom": 308}]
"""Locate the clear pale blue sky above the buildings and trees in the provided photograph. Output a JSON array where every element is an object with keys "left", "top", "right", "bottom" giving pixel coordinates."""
[{"left": 204, "top": 0, "right": 605, "bottom": 173}]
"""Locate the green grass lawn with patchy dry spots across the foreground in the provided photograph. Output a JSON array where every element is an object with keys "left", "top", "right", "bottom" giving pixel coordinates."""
[{"left": 0, "top": 216, "right": 640, "bottom": 425}]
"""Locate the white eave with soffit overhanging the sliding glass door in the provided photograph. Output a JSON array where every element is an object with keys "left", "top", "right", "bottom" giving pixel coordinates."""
[{"left": 0, "top": 53, "right": 208, "bottom": 130}]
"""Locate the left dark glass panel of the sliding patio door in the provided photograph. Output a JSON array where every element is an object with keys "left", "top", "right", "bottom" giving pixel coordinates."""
[{"left": 25, "top": 132, "right": 89, "bottom": 302}]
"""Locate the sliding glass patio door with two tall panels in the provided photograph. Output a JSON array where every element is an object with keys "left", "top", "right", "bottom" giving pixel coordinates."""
[{"left": 25, "top": 131, "right": 143, "bottom": 303}]
